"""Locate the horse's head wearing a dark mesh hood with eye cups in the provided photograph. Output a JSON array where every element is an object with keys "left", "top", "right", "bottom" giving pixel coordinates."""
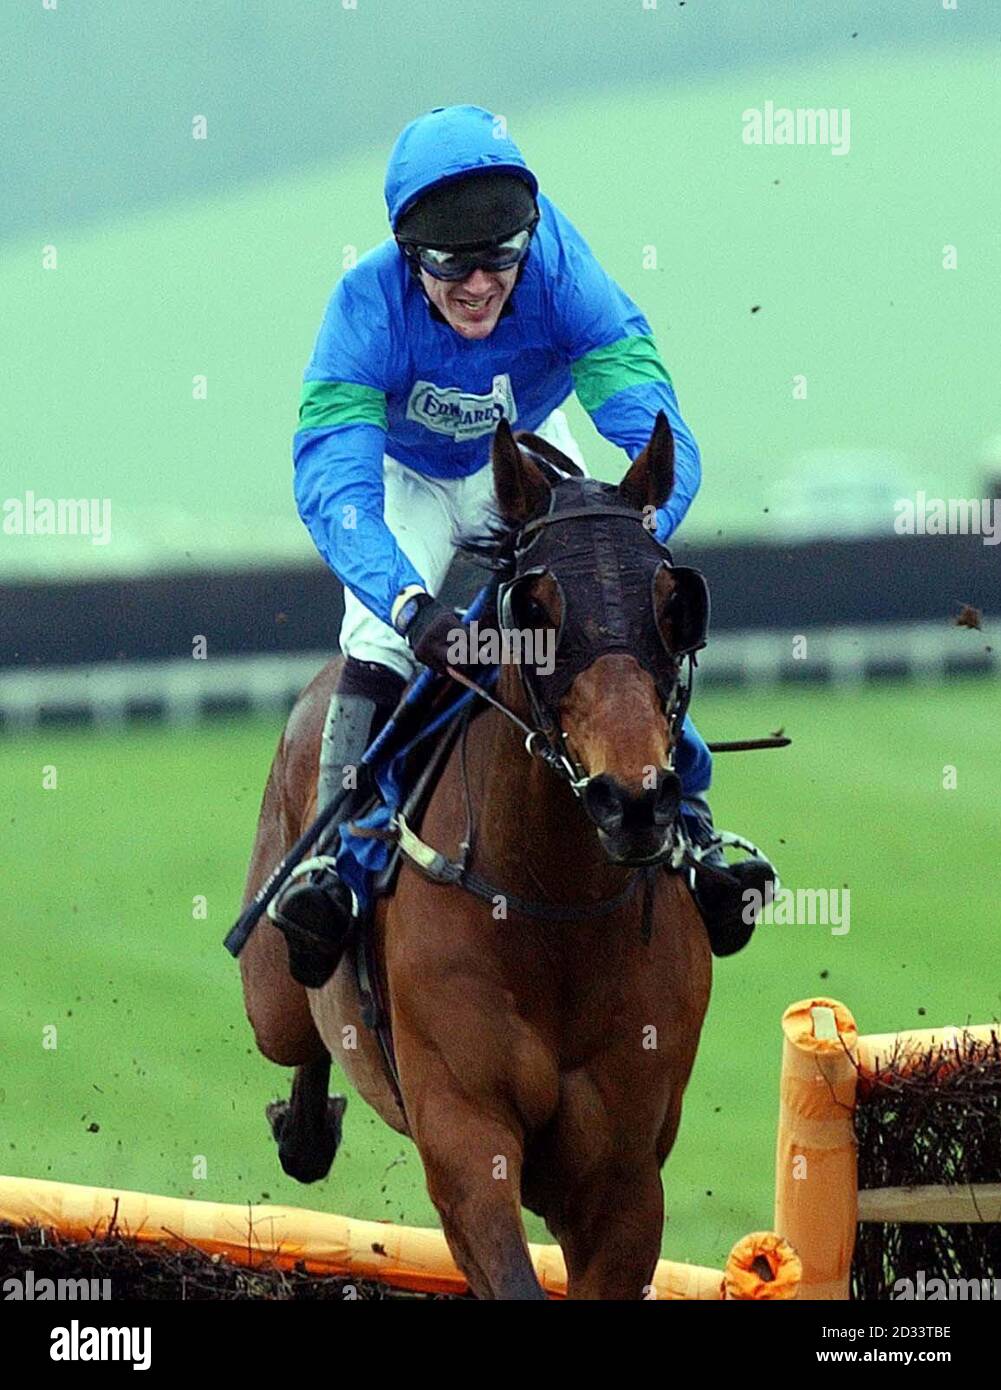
[{"left": 494, "top": 413, "right": 709, "bottom": 863}]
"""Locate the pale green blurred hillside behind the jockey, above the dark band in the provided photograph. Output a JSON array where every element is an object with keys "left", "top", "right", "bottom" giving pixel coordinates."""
[{"left": 0, "top": 49, "right": 1001, "bottom": 574}]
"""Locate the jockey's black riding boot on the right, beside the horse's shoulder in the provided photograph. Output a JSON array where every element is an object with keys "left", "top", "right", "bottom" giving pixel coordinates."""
[{"left": 681, "top": 795, "right": 779, "bottom": 956}]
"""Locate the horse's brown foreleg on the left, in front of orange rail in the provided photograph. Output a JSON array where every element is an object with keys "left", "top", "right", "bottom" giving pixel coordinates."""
[{"left": 407, "top": 1068, "right": 546, "bottom": 1298}]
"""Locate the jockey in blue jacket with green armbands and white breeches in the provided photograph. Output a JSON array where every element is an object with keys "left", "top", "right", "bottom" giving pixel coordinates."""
[{"left": 270, "top": 106, "right": 773, "bottom": 987}]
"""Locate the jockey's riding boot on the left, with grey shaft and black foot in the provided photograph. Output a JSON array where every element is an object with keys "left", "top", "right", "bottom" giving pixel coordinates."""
[{"left": 268, "top": 659, "right": 403, "bottom": 990}]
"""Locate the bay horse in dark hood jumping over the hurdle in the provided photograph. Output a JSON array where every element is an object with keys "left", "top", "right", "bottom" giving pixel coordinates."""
[{"left": 241, "top": 414, "right": 712, "bottom": 1298}]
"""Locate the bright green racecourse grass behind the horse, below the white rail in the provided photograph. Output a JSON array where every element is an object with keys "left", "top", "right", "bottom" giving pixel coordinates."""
[{"left": 0, "top": 681, "right": 1001, "bottom": 1264}]
